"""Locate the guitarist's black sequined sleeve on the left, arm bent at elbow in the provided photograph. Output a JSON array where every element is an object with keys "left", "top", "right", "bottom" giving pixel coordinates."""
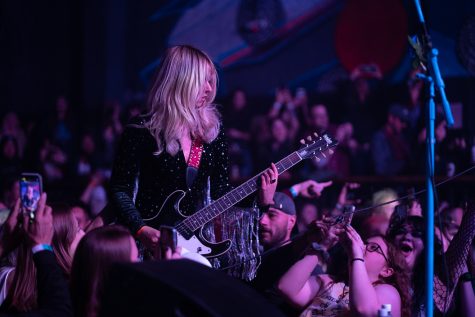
[{"left": 110, "top": 124, "right": 148, "bottom": 233}]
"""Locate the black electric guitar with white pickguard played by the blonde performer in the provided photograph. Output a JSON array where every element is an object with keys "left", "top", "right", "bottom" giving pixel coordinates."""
[{"left": 144, "top": 133, "right": 338, "bottom": 258}]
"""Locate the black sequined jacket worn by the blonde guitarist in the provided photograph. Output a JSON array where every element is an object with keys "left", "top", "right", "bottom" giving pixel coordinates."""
[{"left": 109, "top": 117, "right": 231, "bottom": 233}]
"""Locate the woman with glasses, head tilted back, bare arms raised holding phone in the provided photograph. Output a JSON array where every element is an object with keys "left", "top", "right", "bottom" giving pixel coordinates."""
[{"left": 278, "top": 223, "right": 410, "bottom": 316}]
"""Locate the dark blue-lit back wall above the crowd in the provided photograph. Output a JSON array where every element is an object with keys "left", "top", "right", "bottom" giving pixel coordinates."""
[{"left": 0, "top": 0, "right": 475, "bottom": 129}]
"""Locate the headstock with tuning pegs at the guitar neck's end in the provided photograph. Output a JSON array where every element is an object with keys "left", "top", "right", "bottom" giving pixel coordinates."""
[{"left": 297, "top": 133, "right": 338, "bottom": 161}]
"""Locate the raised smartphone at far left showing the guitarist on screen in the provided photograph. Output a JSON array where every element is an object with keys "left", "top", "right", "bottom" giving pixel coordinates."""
[{"left": 20, "top": 173, "right": 43, "bottom": 219}]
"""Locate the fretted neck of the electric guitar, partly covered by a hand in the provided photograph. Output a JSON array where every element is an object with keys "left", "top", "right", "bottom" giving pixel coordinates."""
[{"left": 182, "top": 152, "right": 302, "bottom": 231}]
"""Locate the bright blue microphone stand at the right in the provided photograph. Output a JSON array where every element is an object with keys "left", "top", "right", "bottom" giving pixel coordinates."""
[{"left": 414, "top": 0, "right": 454, "bottom": 317}]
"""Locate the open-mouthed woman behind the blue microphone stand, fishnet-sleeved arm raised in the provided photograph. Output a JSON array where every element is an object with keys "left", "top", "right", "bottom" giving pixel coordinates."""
[{"left": 387, "top": 201, "right": 475, "bottom": 315}]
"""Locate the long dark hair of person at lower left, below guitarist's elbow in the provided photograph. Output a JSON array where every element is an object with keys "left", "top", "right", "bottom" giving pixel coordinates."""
[{"left": 71, "top": 225, "right": 132, "bottom": 317}]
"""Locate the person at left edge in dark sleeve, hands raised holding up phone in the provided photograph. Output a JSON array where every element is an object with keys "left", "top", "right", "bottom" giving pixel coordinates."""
[{"left": 0, "top": 193, "right": 73, "bottom": 317}]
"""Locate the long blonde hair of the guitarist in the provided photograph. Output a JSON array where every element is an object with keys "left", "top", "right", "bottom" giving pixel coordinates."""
[{"left": 146, "top": 45, "right": 220, "bottom": 155}]
